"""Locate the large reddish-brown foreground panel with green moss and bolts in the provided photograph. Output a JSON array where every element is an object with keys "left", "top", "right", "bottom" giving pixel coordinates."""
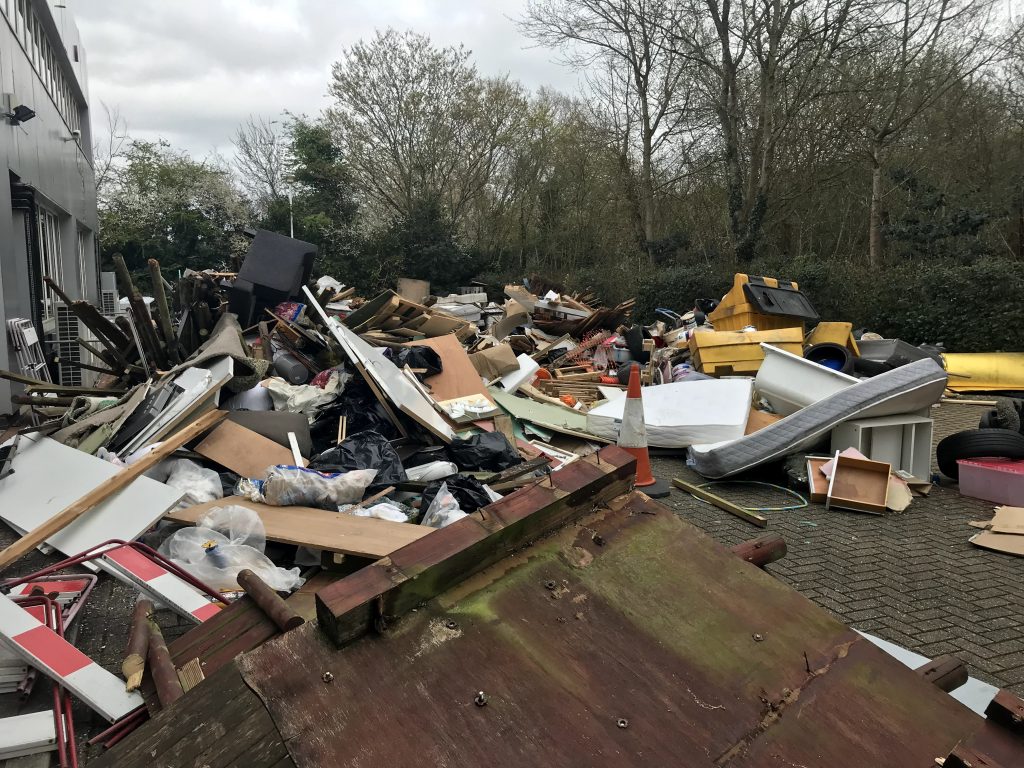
[{"left": 238, "top": 495, "right": 1011, "bottom": 768}]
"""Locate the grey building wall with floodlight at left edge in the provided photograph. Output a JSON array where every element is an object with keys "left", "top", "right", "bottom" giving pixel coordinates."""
[{"left": 0, "top": 0, "right": 98, "bottom": 413}]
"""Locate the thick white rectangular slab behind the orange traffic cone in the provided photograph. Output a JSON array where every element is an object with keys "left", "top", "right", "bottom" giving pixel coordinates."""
[{"left": 587, "top": 378, "right": 754, "bottom": 447}]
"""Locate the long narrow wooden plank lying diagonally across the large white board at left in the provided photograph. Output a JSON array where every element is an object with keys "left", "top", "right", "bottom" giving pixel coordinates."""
[{"left": 0, "top": 411, "right": 226, "bottom": 570}]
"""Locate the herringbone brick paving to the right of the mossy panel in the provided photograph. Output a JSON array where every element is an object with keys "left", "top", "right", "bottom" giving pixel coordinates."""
[{"left": 653, "top": 404, "right": 1024, "bottom": 694}]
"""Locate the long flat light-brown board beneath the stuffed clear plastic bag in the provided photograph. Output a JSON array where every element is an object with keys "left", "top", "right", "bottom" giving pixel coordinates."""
[{"left": 167, "top": 496, "right": 433, "bottom": 559}]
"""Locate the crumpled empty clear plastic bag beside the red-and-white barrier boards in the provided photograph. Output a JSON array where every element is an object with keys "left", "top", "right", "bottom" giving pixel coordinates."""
[{"left": 160, "top": 505, "right": 303, "bottom": 592}]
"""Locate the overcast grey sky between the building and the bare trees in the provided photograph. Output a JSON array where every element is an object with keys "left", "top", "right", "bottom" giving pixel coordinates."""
[{"left": 72, "top": 0, "right": 577, "bottom": 156}]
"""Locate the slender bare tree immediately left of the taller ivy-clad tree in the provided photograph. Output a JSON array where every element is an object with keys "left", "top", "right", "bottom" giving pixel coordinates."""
[{"left": 519, "top": 0, "right": 691, "bottom": 260}]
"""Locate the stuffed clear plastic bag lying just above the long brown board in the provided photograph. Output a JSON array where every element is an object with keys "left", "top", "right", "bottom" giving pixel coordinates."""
[{"left": 239, "top": 465, "right": 377, "bottom": 510}]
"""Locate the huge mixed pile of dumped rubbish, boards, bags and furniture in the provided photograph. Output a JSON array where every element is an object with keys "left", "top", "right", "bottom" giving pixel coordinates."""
[{"left": 0, "top": 231, "right": 1019, "bottom": 765}]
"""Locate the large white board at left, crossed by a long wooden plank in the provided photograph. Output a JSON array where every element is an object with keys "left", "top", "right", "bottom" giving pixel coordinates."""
[{"left": 0, "top": 436, "right": 183, "bottom": 555}]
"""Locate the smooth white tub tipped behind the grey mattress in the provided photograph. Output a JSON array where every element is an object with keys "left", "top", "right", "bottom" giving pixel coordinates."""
[{"left": 754, "top": 342, "right": 859, "bottom": 416}]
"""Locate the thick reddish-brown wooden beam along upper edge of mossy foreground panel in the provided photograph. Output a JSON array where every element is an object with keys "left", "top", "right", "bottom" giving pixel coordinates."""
[{"left": 316, "top": 445, "right": 636, "bottom": 646}]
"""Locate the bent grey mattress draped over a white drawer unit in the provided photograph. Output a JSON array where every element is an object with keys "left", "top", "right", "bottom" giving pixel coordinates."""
[{"left": 690, "top": 359, "right": 946, "bottom": 479}]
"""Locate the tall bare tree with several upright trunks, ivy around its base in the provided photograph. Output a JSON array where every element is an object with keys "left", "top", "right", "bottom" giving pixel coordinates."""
[{"left": 673, "top": 0, "right": 871, "bottom": 260}]
